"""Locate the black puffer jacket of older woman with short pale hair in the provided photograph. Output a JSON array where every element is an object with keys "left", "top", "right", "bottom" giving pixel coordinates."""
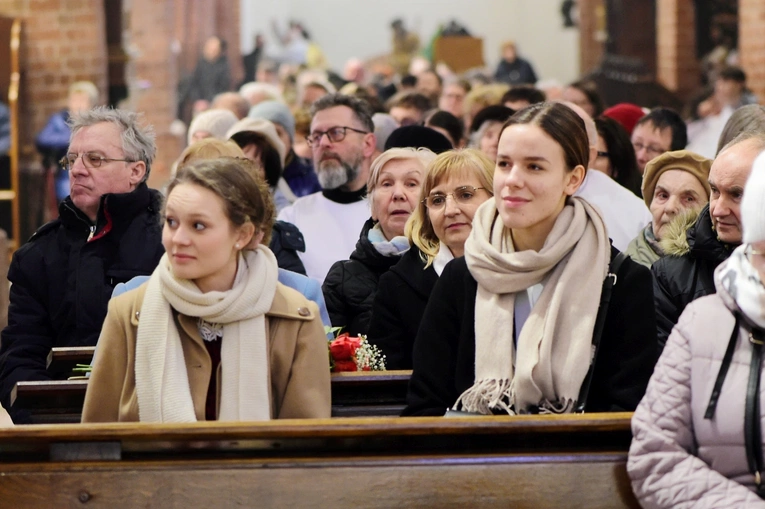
[{"left": 321, "top": 219, "right": 401, "bottom": 336}]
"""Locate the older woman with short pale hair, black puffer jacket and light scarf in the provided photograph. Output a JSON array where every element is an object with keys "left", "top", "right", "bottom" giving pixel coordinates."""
[{"left": 322, "top": 148, "right": 435, "bottom": 335}]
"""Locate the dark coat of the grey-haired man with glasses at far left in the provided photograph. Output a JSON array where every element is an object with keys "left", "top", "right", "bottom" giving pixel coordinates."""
[{"left": 0, "top": 184, "right": 164, "bottom": 421}]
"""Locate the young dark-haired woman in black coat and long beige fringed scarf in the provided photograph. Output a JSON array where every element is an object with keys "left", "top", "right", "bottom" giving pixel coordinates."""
[{"left": 404, "top": 103, "right": 657, "bottom": 415}]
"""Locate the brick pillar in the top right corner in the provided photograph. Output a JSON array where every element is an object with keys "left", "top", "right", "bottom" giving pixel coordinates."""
[{"left": 738, "top": 0, "right": 765, "bottom": 103}]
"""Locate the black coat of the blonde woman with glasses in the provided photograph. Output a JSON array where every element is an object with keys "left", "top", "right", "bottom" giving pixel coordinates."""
[{"left": 369, "top": 246, "right": 438, "bottom": 369}]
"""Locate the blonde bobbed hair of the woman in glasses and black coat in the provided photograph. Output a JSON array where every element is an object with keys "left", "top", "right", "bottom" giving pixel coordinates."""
[{"left": 405, "top": 148, "right": 494, "bottom": 268}]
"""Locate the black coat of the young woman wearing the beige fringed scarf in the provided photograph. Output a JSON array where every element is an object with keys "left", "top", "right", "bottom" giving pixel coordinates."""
[{"left": 404, "top": 248, "right": 658, "bottom": 415}]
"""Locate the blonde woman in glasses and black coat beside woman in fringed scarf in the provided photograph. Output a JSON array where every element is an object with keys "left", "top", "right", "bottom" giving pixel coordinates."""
[{"left": 369, "top": 149, "right": 494, "bottom": 369}]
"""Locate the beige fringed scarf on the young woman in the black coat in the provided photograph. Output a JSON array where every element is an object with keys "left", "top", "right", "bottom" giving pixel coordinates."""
[{"left": 454, "top": 198, "right": 611, "bottom": 414}]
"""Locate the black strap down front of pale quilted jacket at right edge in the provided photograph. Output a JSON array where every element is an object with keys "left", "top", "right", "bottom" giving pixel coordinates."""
[{"left": 744, "top": 329, "right": 765, "bottom": 498}]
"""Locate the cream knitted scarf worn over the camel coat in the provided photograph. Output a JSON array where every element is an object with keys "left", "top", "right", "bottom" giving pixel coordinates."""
[{"left": 135, "top": 246, "right": 278, "bottom": 422}]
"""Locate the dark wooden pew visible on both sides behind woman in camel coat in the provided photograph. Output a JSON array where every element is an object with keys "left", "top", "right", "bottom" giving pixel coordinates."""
[{"left": 11, "top": 368, "right": 411, "bottom": 424}]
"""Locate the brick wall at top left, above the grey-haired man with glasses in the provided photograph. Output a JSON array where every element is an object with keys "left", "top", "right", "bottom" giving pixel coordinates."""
[{"left": 0, "top": 0, "right": 106, "bottom": 167}]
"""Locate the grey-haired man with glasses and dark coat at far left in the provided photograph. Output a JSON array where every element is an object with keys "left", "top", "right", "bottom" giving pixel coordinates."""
[{"left": 0, "top": 108, "right": 163, "bottom": 422}]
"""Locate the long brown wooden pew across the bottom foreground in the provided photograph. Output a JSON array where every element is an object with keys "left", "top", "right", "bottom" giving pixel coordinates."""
[{"left": 0, "top": 414, "right": 639, "bottom": 509}]
